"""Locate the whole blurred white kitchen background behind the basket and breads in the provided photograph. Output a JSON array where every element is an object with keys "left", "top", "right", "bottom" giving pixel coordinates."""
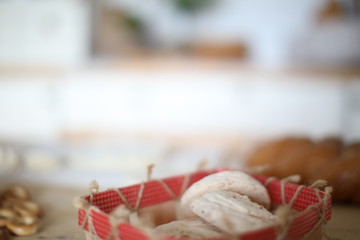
[{"left": 0, "top": 0, "right": 360, "bottom": 186}]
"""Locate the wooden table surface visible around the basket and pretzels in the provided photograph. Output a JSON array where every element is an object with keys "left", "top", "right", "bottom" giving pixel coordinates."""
[{"left": 0, "top": 184, "right": 360, "bottom": 240}]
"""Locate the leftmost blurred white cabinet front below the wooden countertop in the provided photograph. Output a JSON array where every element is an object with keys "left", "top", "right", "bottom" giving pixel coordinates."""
[{"left": 0, "top": 77, "right": 58, "bottom": 140}]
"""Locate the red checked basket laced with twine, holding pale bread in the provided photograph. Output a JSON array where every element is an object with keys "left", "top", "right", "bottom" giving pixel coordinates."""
[{"left": 78, "top": 170, "right": 331, "bottom": 240}]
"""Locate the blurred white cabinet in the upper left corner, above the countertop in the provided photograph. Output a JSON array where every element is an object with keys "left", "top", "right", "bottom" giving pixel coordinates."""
[{"left": 0, "top": 0, "right": 91, "bottom": 66}]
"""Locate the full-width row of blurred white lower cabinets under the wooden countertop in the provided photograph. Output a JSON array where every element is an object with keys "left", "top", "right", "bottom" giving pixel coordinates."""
[{"left": 0, "top": 69, "right": 360, "bottom": 139}]
